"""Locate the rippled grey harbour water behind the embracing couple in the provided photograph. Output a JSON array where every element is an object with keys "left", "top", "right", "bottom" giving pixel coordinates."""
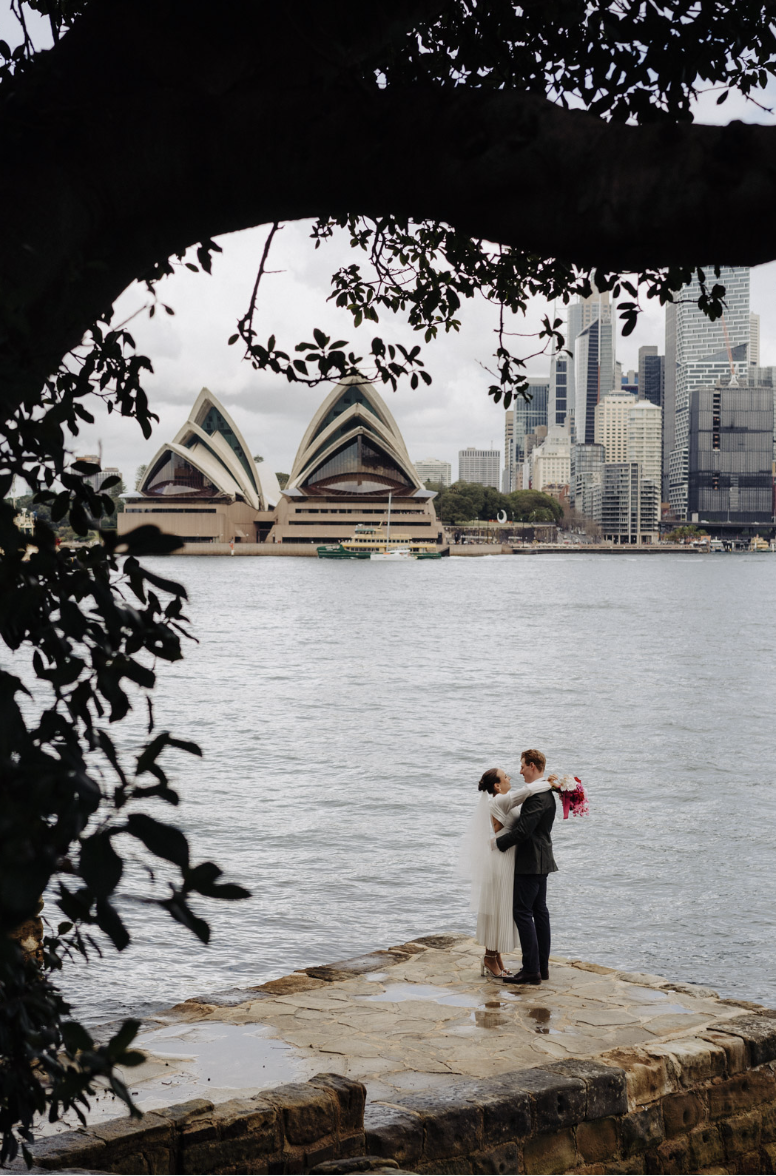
[{"left": 60, "top": 554, "right": 776, "bottom": 1018}]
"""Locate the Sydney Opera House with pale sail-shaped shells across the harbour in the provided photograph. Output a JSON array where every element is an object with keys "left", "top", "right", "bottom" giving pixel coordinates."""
[{"left": 119, "top": 377, "right": 442, "bottom": 544}]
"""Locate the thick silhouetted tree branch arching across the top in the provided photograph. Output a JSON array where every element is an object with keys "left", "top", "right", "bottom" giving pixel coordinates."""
[{"left": 0, "top": 0, "right": 776, "bottom": 407}]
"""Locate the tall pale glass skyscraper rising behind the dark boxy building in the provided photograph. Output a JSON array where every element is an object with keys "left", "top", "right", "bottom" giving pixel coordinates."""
[{"left": 663, "top": 266, "right": 750, "bottom": 519}]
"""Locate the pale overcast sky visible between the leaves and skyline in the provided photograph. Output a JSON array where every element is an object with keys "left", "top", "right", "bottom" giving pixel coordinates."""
[{"left": 0, "top": 5, "right": 776, "bottom": 488}]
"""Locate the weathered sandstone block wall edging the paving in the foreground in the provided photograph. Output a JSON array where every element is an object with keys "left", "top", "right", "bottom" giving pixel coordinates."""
[{"left": 27, "top": 1010, "right": 776, "bottom": 1176}]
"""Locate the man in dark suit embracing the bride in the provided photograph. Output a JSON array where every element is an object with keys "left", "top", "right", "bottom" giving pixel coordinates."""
[{"left": 496, "top": 748, "right": 557, "bottom": 984}]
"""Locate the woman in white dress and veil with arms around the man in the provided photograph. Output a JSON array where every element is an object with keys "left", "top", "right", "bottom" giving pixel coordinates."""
[{"left": 463, "top": 768, "right": 555, "bottom": 977}]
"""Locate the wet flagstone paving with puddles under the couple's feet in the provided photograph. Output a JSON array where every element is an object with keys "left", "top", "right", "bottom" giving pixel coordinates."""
[{"left": 52, "top": 935, "right": 751, "bottom": 1120}]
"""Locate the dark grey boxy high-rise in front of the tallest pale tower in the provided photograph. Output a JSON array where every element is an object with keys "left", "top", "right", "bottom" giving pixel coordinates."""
[{"left": 687, "top": 381, "right": 774, "bottom": 523}]
